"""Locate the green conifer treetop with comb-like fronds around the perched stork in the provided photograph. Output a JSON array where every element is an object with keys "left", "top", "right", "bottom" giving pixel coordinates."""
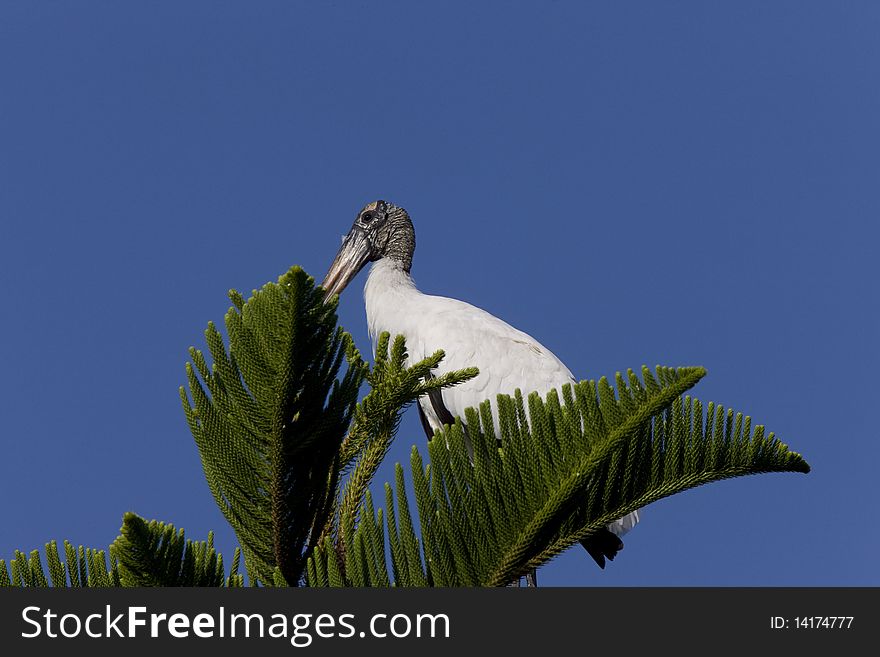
[{"left": 0, "top": 267, "right": 810, "bottom": 587}]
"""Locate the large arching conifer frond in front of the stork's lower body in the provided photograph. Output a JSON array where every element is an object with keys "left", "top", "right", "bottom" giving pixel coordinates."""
[{"left": 308, "top": 367, "right": 809, "bottom": 586}]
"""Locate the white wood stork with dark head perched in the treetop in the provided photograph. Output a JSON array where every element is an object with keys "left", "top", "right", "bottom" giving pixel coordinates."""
[{"left": 321, "top": 201, "right": 639, "bottom": 568}]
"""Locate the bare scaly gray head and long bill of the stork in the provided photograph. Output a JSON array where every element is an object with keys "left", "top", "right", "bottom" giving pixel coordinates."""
[{"left": 321, "top": 201, "right": 416, "bottom": 299}]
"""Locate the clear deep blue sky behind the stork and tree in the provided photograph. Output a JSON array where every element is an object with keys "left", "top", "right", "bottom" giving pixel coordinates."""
[{"left": 0, "top": 2, "right": 880, "bottom": 586}]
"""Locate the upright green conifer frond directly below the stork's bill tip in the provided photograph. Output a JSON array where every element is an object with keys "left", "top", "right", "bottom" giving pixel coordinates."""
[{"left": 180, "top": 267, "right": 366, "bottom": 584}]
